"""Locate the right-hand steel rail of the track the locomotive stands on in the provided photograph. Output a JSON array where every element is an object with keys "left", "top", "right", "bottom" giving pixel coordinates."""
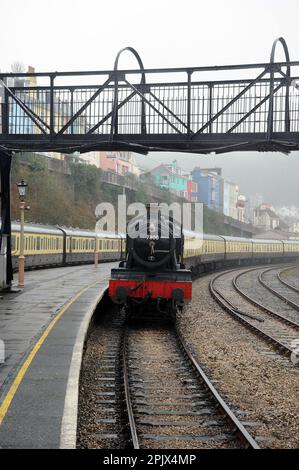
[{"left": 175, "top": 325, "right": 260, "bottom": 449}]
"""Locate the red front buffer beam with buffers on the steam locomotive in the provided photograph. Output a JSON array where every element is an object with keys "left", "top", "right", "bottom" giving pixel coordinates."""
[{"left": 109, "top": 268, "right": 192, "bottom": 304}]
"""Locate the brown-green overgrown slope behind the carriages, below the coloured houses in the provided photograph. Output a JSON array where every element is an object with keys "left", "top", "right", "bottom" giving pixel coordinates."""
[{"left": 12, "top": 153, "right": 240, "bottom": 235}]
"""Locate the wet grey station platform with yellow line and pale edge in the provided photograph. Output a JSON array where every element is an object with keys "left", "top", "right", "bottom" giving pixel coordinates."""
[{"left": 0, "top": 263, "right": 117, "bottom": 449}]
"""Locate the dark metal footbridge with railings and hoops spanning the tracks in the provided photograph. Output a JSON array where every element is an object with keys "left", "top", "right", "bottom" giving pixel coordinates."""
[{"left": 0, "top": 38, "right": 299, "bottom": 152}]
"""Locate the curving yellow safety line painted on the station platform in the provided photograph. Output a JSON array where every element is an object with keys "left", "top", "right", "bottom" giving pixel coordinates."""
[{"left": 0, "top": 281, "right": 101, "bottom": 426}]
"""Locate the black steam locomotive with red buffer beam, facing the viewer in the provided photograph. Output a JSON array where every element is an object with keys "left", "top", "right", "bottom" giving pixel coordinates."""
[{"left": 109, "top": 209, "right": 192, "bottom": 317}]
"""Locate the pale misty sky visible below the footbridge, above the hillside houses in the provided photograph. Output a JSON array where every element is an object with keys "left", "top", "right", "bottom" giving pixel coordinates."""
[{"left": 136, "top": 152, "right": 299, "bottom": 207}]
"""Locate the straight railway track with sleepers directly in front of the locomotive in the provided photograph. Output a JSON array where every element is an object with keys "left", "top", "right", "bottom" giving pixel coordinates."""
[{"left": 79, "top": 310, "right": 259, "bottom": 449}]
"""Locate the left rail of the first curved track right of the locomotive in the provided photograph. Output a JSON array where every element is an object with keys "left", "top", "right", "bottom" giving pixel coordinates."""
[{"left": 209, "top": 272, "right": 293, "bottom": 355}]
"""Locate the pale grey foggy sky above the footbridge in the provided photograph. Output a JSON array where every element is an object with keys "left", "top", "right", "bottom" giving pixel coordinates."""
[{"left": 0, "top": 0, "right": 299, "bottom": 71}]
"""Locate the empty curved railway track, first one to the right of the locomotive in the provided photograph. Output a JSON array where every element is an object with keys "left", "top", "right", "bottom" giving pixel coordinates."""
[{"left": 210, "top": 268, "right": 299, "bottom": 355}]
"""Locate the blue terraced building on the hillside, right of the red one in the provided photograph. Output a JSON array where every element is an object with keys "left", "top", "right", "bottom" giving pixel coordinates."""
[{"left": 191, "top": 167, "right": 223, "bottom": 212}]
